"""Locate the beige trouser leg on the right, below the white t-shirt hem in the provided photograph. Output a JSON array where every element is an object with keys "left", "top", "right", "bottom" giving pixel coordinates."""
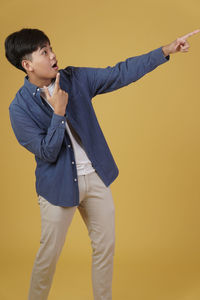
[{"left": 78, "top": 172, "right": 115, "bottom": 300}]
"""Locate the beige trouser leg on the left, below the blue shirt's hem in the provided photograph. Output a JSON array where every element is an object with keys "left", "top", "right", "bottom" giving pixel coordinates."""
[{"left": 28, "top": 196, "right": 76, "bottom": 300}]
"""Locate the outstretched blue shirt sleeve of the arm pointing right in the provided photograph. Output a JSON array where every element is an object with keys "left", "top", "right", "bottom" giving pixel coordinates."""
[{"left": 76, "top": 47, "right": 170, "bottom": 97}]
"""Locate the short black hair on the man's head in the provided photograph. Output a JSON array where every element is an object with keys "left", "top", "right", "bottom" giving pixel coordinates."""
[{"left": 5, "top": 28, "right": 50, "bottom": 73}]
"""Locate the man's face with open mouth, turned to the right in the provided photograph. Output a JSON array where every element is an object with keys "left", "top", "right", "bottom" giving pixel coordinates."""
[{"left": 24, "top": 43, "right": 58, "bottom": 82}]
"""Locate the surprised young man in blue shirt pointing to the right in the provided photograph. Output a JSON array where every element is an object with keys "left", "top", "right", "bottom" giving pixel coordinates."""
[{"left": 5, "top": 29, "right": 200, "bottom": 300}]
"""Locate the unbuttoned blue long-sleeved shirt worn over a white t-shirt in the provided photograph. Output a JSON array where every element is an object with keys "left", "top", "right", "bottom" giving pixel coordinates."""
[{"left": 9, "top": 47, "right": 169, "bottom": 207}]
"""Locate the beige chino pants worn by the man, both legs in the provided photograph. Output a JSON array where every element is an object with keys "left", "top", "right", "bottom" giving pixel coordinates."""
[{"left": 28, "top": 172, "right": 115, "bottom": 300}]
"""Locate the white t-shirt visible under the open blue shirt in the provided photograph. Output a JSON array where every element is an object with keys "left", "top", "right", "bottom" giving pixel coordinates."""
[{"left": 40, "top": 81, "right": 95, "bottom": 176}]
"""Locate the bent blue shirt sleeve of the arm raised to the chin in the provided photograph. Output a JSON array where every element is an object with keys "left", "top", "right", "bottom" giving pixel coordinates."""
[{"left": 9, "top": 104, "right": 65, "bottom": 163}]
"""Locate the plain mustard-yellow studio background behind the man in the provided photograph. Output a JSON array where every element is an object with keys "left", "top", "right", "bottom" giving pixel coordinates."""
[{"left": 0, "top": 0, "right": 200, "bottom": 300}]
